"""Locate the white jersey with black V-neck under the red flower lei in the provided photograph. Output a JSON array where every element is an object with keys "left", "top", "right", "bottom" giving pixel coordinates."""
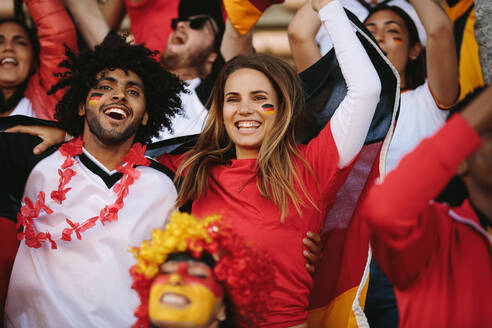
[{"left": 5, "top": 151, "right": 177, "bottom": 328}]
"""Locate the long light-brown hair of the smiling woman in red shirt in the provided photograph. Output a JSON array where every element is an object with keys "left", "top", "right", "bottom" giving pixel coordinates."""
[{"left": 176, "top": 54, "right": 317, "bottom": 221}]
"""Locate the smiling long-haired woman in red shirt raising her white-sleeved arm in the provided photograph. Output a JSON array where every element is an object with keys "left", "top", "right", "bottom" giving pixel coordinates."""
[{"left": 159, "top": 0, "right": 380, "bottom": 327}]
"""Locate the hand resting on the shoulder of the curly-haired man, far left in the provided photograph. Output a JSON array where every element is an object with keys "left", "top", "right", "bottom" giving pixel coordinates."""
[{"left": 4, "top": 125, "right": 66, "bottom": 155}]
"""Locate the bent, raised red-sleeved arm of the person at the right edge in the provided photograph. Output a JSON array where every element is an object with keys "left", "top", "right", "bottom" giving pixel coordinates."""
[{"left": 362, "top": 88, "right": 492, "bottom": 287}]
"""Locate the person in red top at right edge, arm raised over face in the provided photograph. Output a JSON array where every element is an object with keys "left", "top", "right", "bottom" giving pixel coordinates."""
[{"left": 364, "top": 87, "right": 492, "bottom": 328}]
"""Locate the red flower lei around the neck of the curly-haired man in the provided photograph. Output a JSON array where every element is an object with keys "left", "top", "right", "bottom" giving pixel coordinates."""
[{"left": 17, "top": 137, "right": 150, "bottom": 249}]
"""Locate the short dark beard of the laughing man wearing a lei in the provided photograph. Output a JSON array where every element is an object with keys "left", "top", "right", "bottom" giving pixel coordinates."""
[{"left": 86, "top": 112, "right": 143, "bottom": 145}]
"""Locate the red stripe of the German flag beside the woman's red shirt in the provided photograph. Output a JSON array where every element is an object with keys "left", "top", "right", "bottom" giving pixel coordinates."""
[{"left": 310, "top": 142, "right": 382, "bottom": 311}]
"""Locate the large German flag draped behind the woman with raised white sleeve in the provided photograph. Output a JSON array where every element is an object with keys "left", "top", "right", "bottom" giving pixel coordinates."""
[{"left": 300, "top": 10, "right": 400, "bottom": 328}]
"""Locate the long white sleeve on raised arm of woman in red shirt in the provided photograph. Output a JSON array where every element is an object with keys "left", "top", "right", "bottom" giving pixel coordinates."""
[{"left": 319, "top": 0, "right": 381, "bottom": 168}]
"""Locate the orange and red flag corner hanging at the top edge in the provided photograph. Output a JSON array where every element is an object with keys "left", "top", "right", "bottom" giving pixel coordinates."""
[{"left": 223, "top": 0, "right": 284, "bottom": 34}]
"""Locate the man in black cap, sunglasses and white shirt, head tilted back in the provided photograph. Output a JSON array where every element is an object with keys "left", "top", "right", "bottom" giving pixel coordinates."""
[{"left": 153, "top": 0, "right": 225, "bottom": 141}]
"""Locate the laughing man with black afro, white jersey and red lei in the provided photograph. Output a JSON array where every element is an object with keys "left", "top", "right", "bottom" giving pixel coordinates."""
[{"left": 0, "top": 33, "right": 183, "bottom": 327}]
